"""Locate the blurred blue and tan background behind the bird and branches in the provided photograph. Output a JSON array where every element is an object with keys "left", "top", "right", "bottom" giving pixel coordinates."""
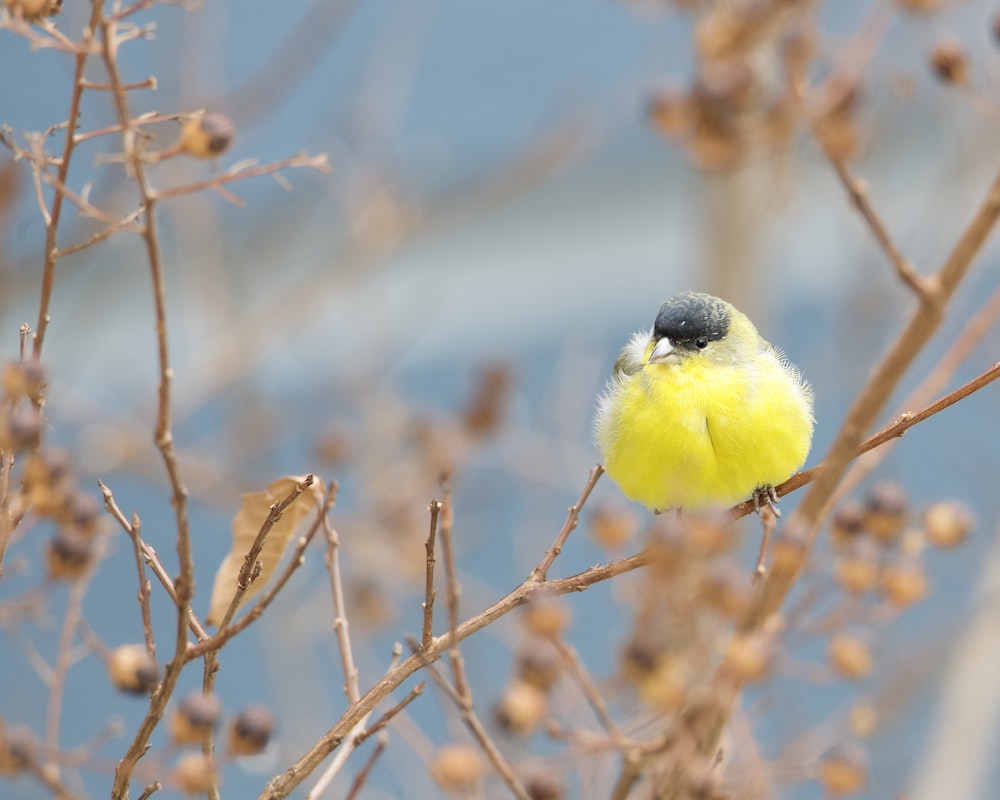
[{"left": 0, "top": 0, "right": 1000, "bottom": 798}]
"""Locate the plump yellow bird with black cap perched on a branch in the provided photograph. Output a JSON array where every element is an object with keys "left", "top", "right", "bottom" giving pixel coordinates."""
[{"left": 594, "top": 292, "right": 814, "bottom": 511}]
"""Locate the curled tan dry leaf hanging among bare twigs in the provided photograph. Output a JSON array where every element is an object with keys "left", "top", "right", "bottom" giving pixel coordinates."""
[{"left": 205, "top": 475, "right": 326, "bottom": 625}]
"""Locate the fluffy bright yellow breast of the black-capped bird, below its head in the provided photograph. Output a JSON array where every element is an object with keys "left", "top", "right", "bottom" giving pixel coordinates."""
[{"left": 597, "top": 349, "right": 813, "bottom": 510}]
